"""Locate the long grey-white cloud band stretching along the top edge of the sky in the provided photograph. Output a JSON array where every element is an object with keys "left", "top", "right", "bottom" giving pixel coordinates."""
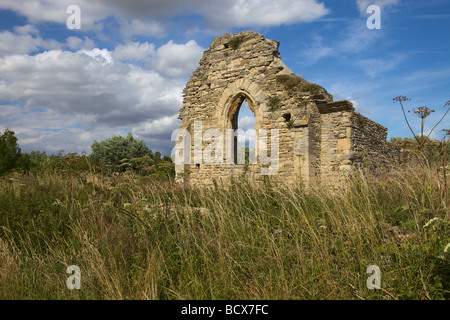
[{"left": 0, "top": 0, "right": 329, "bottom": 32}]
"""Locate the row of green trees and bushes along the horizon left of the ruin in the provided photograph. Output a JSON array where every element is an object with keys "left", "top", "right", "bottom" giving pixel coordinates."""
[{"left": 0, "top": 129, "right": 175, "bottom": 177}]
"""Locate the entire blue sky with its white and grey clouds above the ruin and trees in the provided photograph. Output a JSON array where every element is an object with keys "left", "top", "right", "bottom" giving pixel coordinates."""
[{"left": 0, "top": 0, "right": 450, "bottom": 154}]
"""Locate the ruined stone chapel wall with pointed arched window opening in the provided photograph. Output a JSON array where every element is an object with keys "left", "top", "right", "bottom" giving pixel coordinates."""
[{"left": 176, "top": 31, "right": 400, "bottom": 187}]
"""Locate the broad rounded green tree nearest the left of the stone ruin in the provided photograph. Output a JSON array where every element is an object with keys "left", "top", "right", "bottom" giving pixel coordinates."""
[{"left": 89, "top": 132, "right": 153, "bottom": 171}]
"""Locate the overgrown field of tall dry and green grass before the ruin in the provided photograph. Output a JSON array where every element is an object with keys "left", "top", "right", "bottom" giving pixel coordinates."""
[{"left": 0, "top": 168, "right": 450, "bottom": 299}]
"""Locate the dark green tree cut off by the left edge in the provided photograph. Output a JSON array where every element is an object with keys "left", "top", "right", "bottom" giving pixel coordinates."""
[{"left": 0, "top": 129, "right": 21, "bottom": 175}]
